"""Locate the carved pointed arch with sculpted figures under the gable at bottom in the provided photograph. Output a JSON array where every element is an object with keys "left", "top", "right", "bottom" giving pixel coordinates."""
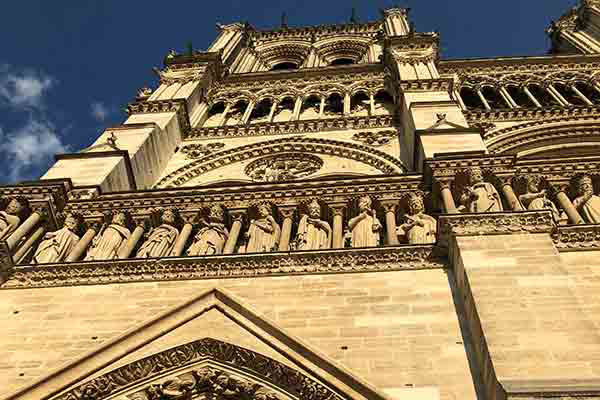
[{"left": 53, "top": 338, "right": 346, "bottom": 400}]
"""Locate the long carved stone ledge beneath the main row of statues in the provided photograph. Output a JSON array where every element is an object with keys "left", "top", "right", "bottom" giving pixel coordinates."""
[{"left": 2, "top": 245, "right": 446, "bottom": 289}]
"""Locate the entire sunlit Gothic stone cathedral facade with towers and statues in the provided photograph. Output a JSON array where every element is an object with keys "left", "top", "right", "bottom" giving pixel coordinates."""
[{"left": 0, "top": 0, "right": 600, "bottom": 400}]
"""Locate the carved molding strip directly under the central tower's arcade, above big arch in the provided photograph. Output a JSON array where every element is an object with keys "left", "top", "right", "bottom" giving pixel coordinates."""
[{"left": 185, "top": 115, "right": 396, "bottom": 140}]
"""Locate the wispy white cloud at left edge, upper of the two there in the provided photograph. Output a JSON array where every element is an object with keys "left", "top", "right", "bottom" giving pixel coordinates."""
[{"left": 0, "top": 66, "right": 55, "bottom": 108}]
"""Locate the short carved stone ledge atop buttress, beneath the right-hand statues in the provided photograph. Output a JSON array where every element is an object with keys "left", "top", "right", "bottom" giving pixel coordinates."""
[{"left": 438, "top": 211, "right": 555, "bottom": 247}]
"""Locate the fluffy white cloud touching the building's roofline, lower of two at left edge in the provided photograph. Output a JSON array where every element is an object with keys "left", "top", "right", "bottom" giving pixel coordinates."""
[{"left": 0, "top": 119, "right": 68, "bottom": 181}]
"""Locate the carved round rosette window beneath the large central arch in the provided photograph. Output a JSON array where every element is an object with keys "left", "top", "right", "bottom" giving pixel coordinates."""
[{"left": 245, "top": 153, "right": 323, "bottom": 182}]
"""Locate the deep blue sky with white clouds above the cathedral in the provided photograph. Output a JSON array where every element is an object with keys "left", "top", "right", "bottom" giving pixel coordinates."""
[{"left": 0, "top": 0, "right": 576, "bottom": 183}]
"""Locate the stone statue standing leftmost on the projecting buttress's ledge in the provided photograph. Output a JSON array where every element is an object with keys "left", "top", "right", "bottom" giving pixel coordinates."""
[{"left": 460, "top": 167, "right": 503, "bottom": 213}]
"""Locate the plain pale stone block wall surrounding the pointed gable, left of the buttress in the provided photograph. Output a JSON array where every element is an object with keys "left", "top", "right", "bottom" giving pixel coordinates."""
[{"left": 0, "top": 269, "right": 476, "bottom": 400}]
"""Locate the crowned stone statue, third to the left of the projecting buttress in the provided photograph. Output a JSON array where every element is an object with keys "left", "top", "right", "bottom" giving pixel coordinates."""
[{"left": 296, "top": 200, "right": 332, "bottom": 250}]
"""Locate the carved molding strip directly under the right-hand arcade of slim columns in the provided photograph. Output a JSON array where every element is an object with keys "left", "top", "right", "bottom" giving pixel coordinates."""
[{"left": 463, "top": 105, "right": 600, "bottom": 123}]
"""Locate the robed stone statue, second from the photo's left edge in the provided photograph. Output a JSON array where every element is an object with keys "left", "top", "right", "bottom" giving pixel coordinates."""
[{"left": 31, "top": 214, "right": 80, "bottom": 264}]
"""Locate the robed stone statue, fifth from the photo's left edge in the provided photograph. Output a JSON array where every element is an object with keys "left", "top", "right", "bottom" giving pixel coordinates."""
[{"left": 186, "top": 204, "right": 229, "bottom": 256}]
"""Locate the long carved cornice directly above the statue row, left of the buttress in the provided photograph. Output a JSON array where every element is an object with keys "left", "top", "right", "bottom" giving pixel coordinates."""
[{"left": 66, "top": 175, "right": 422, "bottom": 219}]
